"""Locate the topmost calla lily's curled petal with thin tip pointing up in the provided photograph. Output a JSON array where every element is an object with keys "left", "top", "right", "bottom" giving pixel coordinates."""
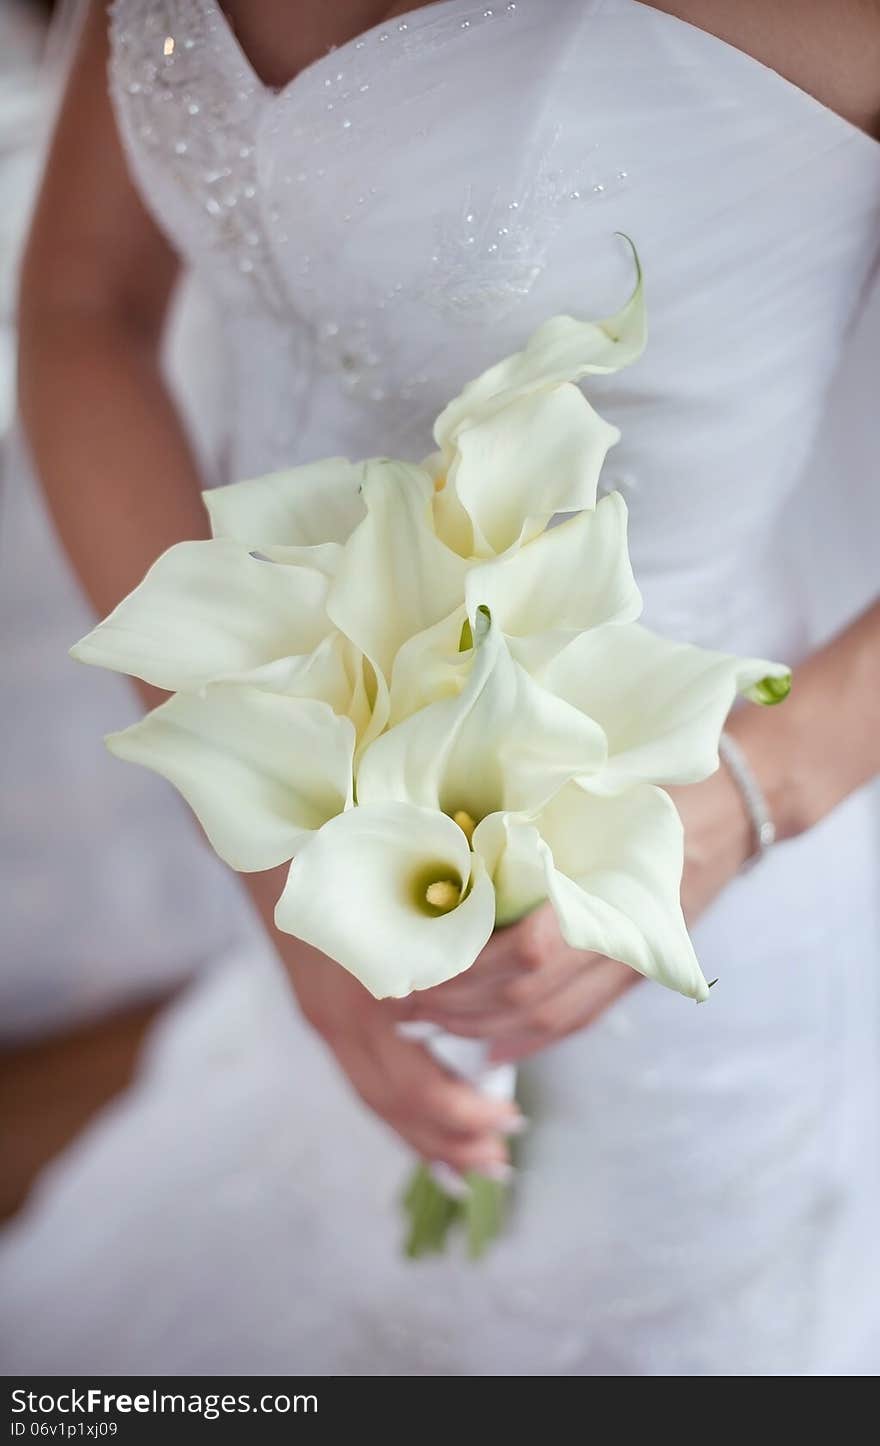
[{"left": 433, "top": 241, "right": 647, "bottom": 466}]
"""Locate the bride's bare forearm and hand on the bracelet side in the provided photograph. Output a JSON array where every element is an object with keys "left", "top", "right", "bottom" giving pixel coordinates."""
[{"left": 413, "top": 602, "right": 880, "bottom": 1060}]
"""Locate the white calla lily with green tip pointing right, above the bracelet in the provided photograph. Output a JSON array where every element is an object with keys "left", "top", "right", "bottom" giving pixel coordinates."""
[{"left": 539, "top": 623, "right": 789, "bottom": 792}]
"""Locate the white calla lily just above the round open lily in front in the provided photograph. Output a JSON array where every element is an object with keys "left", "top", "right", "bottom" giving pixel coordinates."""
[{"left": 357, "top": 613, "right": 605, "bottom": 820}]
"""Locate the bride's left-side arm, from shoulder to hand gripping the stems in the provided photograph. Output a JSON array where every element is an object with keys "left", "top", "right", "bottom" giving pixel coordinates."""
[{"left": 19, "top": 0, "right": 510, "bottom": 1168}]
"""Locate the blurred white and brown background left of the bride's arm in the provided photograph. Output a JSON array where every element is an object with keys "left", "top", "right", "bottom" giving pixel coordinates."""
[{"left": 0, "top": 0, "right": 249, "bottom": 1220}]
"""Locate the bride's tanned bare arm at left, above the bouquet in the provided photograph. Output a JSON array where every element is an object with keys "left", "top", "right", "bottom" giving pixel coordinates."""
[{"left": 19, "top": 3, "right": 207, "bottom": 701}]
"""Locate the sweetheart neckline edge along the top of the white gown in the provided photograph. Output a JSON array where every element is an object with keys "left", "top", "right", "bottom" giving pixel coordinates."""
[{"left": 207, "top": 0, "right": 880, "bottom": 158}]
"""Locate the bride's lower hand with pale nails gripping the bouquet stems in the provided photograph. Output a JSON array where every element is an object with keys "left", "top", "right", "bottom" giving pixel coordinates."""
[{"left": 285, "top": 940, "right": 519, "bottom": 1174}]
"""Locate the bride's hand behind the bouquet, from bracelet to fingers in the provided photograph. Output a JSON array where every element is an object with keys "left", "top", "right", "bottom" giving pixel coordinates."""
[{"left": 409, "top": 769, "right": 750, "bottom": 1063}]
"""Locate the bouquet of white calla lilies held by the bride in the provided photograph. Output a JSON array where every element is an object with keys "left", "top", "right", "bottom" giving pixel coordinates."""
[{"left": 72, "top": 248, "right": 789, "bottom": 1254}]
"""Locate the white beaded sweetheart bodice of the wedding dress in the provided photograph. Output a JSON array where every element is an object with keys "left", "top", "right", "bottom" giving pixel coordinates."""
[{"left": 111, "top": 0, "right": 880, "bottom": 651}]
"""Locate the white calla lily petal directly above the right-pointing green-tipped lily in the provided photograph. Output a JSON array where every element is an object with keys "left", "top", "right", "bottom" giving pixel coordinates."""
[{"left": 465, "top": 492, "right": 642, "bottom": 671}]
